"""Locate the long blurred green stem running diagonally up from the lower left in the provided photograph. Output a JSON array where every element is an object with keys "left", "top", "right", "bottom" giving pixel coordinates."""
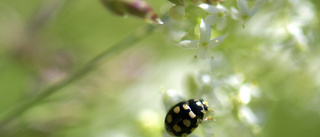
[{"left": 0, "top": 25, "right": 155, "bottom": 128}]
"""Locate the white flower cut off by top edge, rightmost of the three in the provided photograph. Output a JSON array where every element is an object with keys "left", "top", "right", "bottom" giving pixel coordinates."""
[{"left": 231, "top": 0, "right": 268, "bottom": 27}]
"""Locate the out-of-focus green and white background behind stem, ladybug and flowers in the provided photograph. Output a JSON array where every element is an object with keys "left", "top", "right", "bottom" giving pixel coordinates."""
[{"left": 0, "top": 0, "right": 320, "bottom": 137}]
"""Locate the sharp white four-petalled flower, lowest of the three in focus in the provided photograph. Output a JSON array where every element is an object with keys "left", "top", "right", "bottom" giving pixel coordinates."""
[{"left": 178, "top": 19, "right": 226, "bottom": 59}]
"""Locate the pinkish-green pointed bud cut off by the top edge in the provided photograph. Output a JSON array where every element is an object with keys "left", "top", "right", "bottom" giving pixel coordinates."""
[{"left": 101, "top": 0, "right": 162, "bottom": 24}]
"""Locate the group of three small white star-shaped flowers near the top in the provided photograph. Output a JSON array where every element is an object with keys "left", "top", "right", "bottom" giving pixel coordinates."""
[{"left": 178, "top": 0, "right": 268, "bottom": 59}]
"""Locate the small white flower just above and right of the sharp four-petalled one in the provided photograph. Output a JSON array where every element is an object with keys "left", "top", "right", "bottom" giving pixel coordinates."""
[{"left": 199, "top": 3, "right": 228, "bottom": 30}]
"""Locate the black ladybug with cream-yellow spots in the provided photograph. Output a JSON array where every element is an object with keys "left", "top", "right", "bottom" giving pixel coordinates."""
[{"left": 164, "top": 99, "right": 214, "bottom": 136}]
